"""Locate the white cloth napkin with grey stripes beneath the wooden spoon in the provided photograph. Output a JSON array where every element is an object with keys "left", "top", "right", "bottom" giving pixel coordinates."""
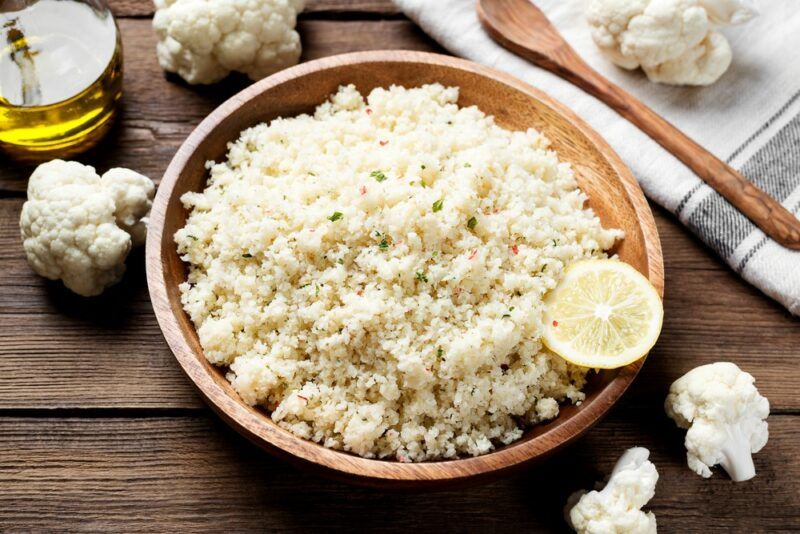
[{"left": 394, "top": 0, "right": 800, "bottom": 315}]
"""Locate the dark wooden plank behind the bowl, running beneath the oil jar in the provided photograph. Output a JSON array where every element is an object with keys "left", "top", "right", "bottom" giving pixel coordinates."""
[{"left": 0, "top": 19, "right": 438, "bottom": 194}]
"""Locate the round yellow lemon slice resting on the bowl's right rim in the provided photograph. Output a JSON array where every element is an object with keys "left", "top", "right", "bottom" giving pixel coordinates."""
[{"left": 544, "top": 260, "right": 664, "bottom": 369}]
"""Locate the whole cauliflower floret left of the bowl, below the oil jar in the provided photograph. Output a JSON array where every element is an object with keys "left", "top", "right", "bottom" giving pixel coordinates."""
[{"left": 19, "top": 160, "right": 154, "bottom": 297}]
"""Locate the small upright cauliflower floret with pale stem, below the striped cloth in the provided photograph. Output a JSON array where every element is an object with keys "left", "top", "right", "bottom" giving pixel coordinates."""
[{"left": 664, "top": 362, "right": 769, "bottom": 482}]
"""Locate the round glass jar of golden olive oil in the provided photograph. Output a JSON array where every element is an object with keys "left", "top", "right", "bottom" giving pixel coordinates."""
[{"left": 0, "top": 0, "right": 122, "bottom": 157}]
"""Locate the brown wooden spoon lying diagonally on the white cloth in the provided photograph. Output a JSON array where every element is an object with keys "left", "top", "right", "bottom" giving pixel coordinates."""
[{"left": 478, "top": 0, "right": 800, "bottom": 250}]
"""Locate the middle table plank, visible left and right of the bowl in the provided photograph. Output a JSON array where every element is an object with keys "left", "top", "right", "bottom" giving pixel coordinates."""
[{"left": 0, "top": 199, "right": 800, "bottom": 412}]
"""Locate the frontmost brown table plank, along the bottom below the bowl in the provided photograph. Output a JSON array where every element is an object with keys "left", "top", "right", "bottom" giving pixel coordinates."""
[{"left": 0, "top": 407, "right": 800, "bottom": 532}]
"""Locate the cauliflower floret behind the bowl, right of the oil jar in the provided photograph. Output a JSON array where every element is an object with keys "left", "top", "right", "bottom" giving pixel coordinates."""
[{"left": 153, "top": 0, "right": 305, "bottom": 84}]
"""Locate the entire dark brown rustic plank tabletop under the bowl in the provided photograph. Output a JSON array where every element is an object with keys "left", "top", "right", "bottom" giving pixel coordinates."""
[{"left": 0, "top": 0, "right": 800, "bottom": 532}]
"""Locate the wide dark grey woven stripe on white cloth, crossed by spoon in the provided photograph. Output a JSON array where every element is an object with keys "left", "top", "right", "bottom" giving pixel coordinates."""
[{"left": 687, "top": 115, "right": 800, "bottom": 262}]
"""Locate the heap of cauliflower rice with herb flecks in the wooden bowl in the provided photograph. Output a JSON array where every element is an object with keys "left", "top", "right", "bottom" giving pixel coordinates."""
[{"left": 175, "top": 84, "right": 621, "bottom": 461}]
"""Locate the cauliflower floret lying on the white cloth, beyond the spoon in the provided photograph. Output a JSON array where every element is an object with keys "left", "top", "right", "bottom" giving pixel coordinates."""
[{"left": 587, "top": 0, "right": 755, "bottom": 85}]
